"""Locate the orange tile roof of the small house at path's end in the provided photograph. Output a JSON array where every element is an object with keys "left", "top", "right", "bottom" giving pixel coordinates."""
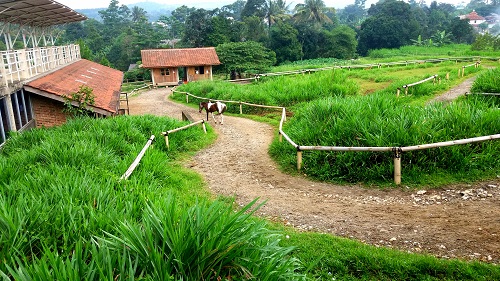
[{"left": 141, "top": 47, "right": 220, "bottom": 68}]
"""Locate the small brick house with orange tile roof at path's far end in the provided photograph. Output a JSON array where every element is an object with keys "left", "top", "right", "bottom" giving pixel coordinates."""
[{"left": 141, "top": 47, "right": 221, "bottom": 86}]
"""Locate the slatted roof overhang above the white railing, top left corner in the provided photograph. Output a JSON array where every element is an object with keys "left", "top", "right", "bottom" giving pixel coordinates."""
[{"left": 0, "top": 0, "right": 87, "bottom": 27}]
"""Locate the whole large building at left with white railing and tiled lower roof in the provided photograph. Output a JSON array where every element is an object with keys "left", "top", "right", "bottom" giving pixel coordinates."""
[{"left": 0, "top": 0, "right": 123, "bottom": 146}]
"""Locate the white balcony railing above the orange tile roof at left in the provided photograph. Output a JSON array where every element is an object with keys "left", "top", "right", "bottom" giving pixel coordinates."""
[{"left": 0, "top": 44, "right": 80, "bottom": 86}]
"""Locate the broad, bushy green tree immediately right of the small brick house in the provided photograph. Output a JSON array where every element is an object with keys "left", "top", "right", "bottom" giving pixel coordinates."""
[{"left": 216, "top": 41, "right": 276, "bottom": 78}]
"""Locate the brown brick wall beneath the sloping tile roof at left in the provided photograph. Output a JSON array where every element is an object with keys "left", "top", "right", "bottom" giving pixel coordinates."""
[{"left": 31, "top": 95, "right": 67, "bottom": 128}]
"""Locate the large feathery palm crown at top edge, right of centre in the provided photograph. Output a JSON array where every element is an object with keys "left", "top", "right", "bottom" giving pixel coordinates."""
[{"left": 293, "top": 0, "right": 333, "bottom": 24}]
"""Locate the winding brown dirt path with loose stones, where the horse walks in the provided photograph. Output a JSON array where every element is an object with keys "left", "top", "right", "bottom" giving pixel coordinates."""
[{"left": 126, "top": 89, "right": 500, "bottom": 263}]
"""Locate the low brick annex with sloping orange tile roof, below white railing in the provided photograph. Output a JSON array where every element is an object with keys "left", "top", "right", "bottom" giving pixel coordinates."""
[{"left": 23, "top": 59, "right": 123, "bottom": 128}]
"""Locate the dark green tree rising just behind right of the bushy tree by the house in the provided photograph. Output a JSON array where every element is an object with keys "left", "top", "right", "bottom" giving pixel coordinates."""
[{"left": 271, "top": 22, "right": 303, "bottom": 63}]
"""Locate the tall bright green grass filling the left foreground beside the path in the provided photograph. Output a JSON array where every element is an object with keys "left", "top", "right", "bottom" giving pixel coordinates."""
[{"left": 0, "top": 116, "right": 301, "bottom": 280}]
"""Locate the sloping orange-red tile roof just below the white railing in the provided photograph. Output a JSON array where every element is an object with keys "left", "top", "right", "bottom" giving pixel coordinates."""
[{"left": 25, "top": 59, "right": 123, "bottom": 113}]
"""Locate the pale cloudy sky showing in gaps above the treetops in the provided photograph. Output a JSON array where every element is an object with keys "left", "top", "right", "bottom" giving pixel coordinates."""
[{"left": 55, "top": 0, "right": 469, "bottom": 9}]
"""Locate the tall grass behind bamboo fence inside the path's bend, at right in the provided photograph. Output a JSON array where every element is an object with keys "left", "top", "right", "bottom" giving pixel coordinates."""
[{"left": 270, "top": 94, "right": 500, "bottom": 185}]
